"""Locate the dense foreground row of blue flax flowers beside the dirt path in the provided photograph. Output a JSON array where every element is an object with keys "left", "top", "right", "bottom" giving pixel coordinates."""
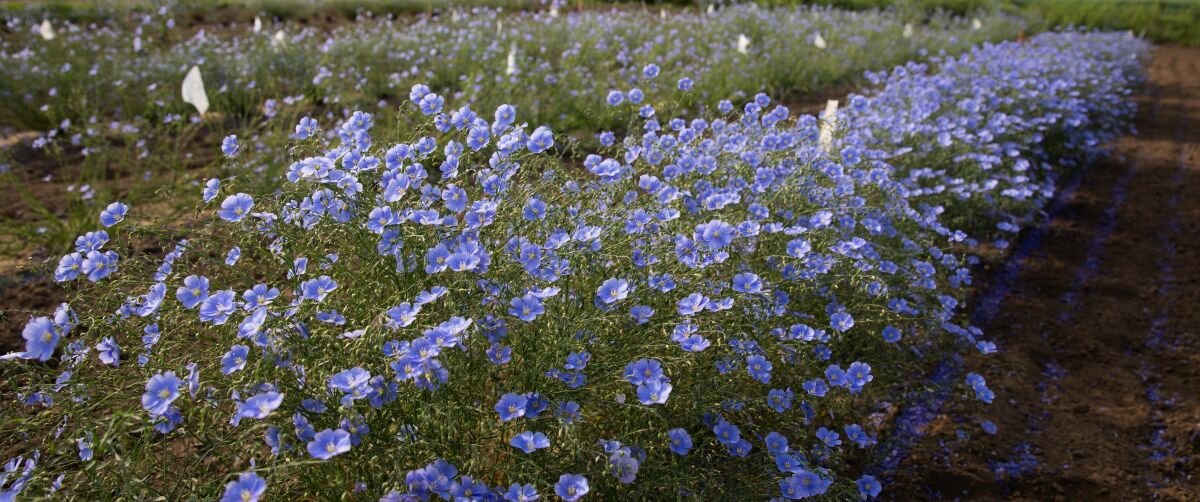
[{"left": 2, "top": 32, "right": 1146, "bottom": 501}]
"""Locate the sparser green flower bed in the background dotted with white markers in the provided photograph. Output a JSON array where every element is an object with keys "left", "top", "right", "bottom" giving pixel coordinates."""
[{"left": 0, "top": 5, "right": 1026, "bottom": 132}]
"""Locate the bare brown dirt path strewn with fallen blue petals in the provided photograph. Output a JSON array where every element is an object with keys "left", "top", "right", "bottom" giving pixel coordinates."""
[{"left": 890, "top": 47, "right": 1200, "bottom": 501}]
